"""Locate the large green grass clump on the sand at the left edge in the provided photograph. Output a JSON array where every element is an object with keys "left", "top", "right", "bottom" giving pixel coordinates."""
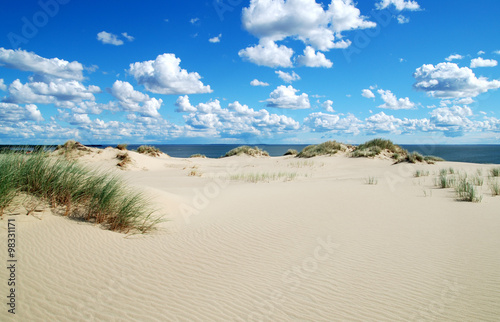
[{"left": 0, "top": 153, "right": 159, "bottom": 232}]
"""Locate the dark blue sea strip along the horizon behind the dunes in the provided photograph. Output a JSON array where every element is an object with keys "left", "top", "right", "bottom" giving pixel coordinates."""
[{"left": 0, "top": 144, "right": 500, "bottom": 164}]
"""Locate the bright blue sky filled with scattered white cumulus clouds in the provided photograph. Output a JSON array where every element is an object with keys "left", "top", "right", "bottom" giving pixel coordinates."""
[{"left": 0, "top": 0, "right": 500, "bottom": 144}]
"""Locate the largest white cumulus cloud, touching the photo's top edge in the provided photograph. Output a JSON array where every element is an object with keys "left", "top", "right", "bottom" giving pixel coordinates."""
[{"left": 239, "top": 0, "right": 376, "bottom": 67}]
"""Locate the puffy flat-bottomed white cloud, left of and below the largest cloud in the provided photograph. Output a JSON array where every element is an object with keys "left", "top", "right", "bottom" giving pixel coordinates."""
[{"left": 128, "top": 54, "right": 212, "bottom": 94}]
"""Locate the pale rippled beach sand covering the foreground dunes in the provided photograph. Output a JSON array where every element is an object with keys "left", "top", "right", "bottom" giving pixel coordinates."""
[{"left": 0, "top": 149, "right": 500, "bottom": 321}]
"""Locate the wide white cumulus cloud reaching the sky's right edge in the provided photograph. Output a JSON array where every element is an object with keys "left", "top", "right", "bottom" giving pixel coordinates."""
[{"left": 413, "top": 63, "right": 500, "bottom": 98}]
